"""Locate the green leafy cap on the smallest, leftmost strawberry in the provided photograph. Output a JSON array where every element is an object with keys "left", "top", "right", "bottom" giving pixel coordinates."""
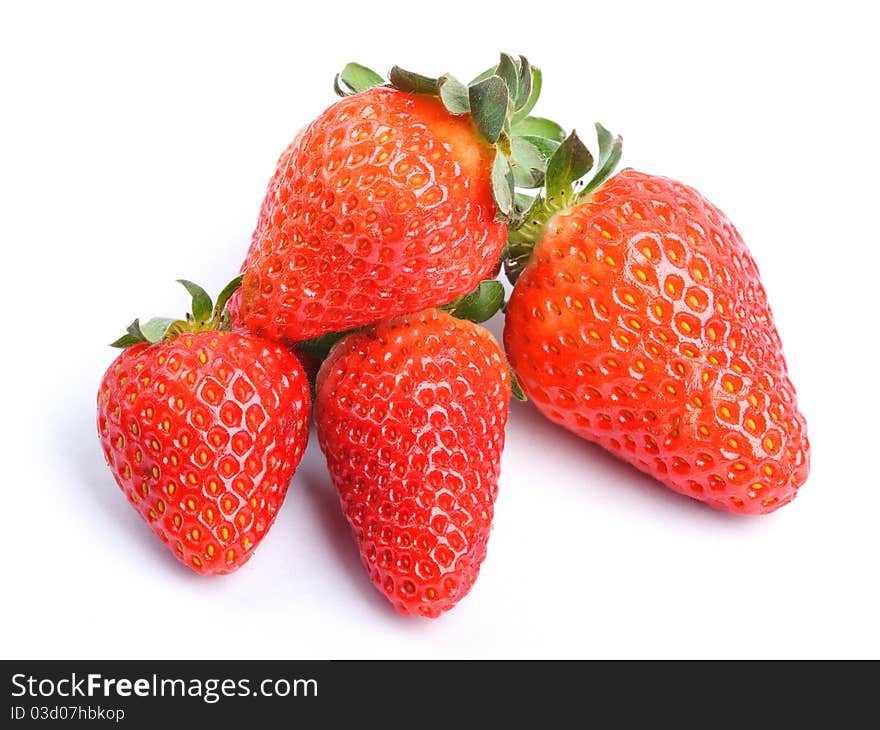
[{"left": 110, "top": 275, "right": 248, "bottom": 348}]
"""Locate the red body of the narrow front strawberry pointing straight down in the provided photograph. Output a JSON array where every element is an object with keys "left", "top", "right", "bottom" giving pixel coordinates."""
[{"left": 315, "top": 310, "right": 510, "bottom": 618}]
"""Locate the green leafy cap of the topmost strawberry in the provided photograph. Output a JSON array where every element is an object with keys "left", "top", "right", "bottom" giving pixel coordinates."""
[{"left": 334, "top": 53, "right": 565, "bottom": 223}]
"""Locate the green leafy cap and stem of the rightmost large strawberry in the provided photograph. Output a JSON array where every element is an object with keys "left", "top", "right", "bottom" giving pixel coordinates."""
[{"left": 503, "top": 122, "right": 623, "bottom": 284}]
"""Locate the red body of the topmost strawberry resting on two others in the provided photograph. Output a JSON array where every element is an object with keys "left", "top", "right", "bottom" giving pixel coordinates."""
[{"left": 240, "top": 88, "right": 506, "bottom": 342}]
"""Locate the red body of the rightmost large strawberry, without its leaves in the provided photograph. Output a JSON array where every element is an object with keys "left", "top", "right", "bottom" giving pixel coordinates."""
[{"left": 504, "top": 171, "right": 810, "bottom": 514}]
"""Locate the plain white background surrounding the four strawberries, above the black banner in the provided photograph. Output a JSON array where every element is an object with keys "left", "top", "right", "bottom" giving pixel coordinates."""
[{"left": 0, "top": 0, "right": 880, "bottom": 658}]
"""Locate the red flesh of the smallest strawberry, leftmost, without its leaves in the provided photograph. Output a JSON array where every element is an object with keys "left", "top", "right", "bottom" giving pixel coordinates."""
[{"left": 98, "top": 331, "right": 309, "bottom": 575}]
